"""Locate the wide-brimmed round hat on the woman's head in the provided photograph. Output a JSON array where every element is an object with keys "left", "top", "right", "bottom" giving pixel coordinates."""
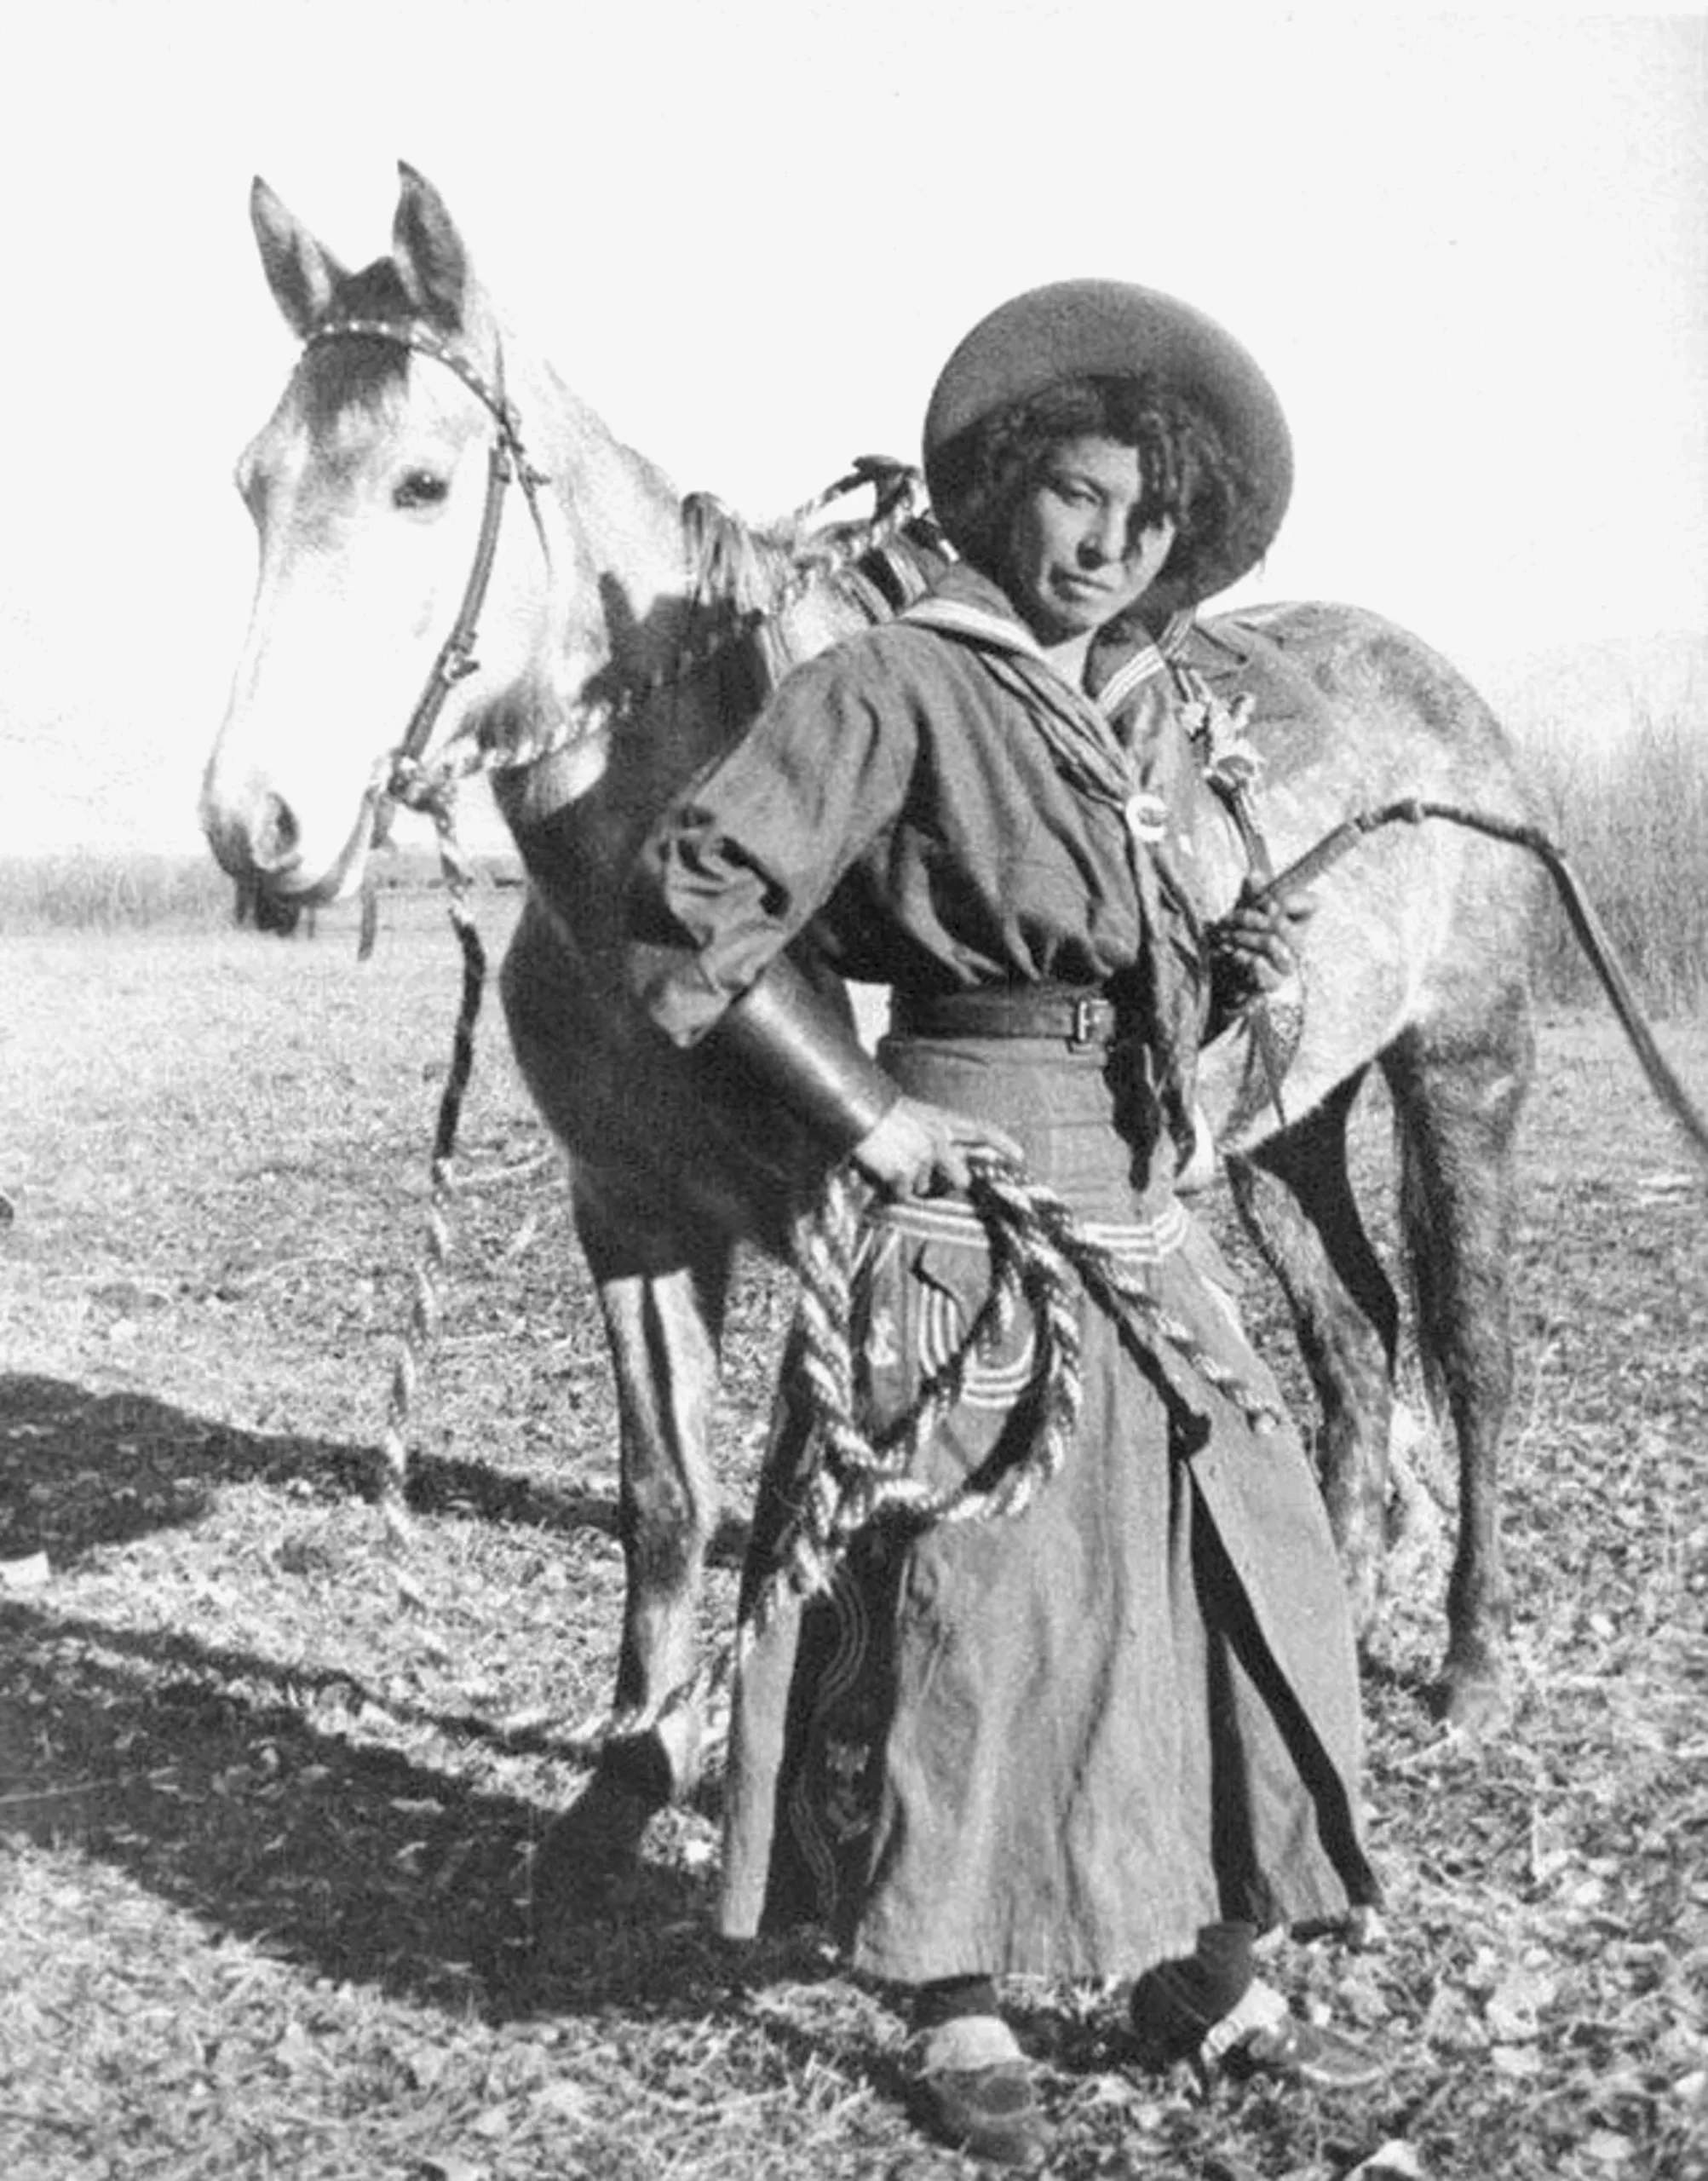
[{"left": 925, "top": 279, "right": 1293, "bottom": 607}]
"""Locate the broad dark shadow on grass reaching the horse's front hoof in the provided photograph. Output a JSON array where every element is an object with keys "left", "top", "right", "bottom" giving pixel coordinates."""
[{"left": 0, "top": 1603, "right": 807, "bottom": 2020}]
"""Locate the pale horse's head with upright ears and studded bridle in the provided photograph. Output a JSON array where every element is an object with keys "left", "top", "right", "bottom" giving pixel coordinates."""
[{"left": 203, "top": 168, "right": 608, "bottom": 901}]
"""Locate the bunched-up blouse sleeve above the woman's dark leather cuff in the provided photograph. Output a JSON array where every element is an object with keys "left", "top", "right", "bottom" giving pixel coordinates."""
[{"left": 628, "top": 639, "right": 916, "bottom": 1044}]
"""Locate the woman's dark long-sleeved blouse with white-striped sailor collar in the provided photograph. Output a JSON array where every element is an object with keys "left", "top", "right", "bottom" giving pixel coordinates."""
[{"left": 635, "top": 567, "right": 1202, "bottom": 1099}]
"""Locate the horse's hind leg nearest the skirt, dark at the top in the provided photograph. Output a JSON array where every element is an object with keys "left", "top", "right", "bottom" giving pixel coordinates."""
[{"left": 1228, "top": 1071, "right": 1400, "bottom": 1636}]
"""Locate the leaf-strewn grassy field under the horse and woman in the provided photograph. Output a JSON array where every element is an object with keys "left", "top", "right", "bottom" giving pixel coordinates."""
[{"left": 0, "top": 896, "right": 1708, "bottom": 2181}]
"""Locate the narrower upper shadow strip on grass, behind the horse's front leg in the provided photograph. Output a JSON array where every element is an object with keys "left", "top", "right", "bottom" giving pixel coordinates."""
[{"left": 0, "top": 1374, "right": 746, "bottom": 1568}]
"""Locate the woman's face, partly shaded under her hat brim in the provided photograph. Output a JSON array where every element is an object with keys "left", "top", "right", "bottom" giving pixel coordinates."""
[{"left": 1008, "top": 434, "right": 1176, "bottom": 643}]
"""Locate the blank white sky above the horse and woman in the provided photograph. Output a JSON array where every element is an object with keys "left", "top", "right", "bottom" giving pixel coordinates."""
[{"left": 0, "top": 0, "right": 1708, "bottom": 853}]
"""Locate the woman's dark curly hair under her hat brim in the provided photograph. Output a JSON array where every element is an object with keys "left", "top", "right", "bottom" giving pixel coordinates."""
[{"left": 936, "top": 377, "right": 1263, "bottom": 591}]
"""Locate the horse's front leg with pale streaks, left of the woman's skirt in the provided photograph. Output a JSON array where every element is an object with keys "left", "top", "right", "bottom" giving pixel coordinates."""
[{"left": 534, "top": 1180, "right": 731, "bottom": 1915}]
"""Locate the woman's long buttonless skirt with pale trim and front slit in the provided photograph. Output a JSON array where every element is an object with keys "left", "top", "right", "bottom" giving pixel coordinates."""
[{"left": 722, "top": 1039, "right": 1377, "bottom": 1982}]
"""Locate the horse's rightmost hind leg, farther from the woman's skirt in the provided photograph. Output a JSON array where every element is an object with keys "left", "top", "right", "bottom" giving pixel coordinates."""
[{"left": 1383, "top": 990, "right": 1536, "bottom": 1732}]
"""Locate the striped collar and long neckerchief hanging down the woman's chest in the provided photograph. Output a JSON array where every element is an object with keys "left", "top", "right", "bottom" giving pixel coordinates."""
[{"left": 901, "top": 562, "right": 1204, "bottom": 1158}]
